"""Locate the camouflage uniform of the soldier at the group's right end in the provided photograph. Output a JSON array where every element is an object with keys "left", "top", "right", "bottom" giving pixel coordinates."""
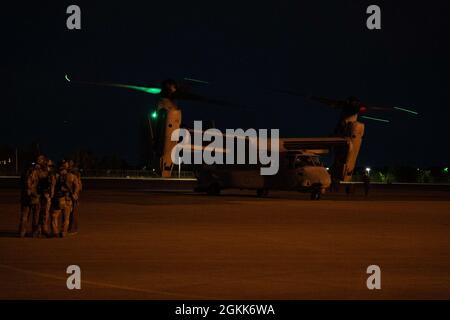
[{"left": 52, "top": 162, "right": 80, "bottom": 237}]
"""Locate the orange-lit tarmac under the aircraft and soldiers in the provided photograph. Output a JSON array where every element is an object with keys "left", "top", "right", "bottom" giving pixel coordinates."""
[{"left": 0, "top": 181, "right": 450, "bottom": 300}]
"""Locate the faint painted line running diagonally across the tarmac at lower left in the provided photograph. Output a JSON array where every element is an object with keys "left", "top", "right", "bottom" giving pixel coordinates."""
[{"left": 0, "top": 264, "right": 217, "bottom": 300}]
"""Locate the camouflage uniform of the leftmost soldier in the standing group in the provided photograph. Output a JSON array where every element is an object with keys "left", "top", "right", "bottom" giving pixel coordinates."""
[{"left": 19, "top": 164, "right": 40, "bottom": 238}]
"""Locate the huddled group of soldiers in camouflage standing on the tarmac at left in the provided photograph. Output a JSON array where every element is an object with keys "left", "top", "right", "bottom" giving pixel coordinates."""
[{"left": 19, "top": 155, "right": 82, "bottom": 237}]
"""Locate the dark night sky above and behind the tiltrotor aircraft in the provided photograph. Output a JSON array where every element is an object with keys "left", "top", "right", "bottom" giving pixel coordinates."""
[{"left": 4, "top": 1, "right": 450, "bottom": 166}]
